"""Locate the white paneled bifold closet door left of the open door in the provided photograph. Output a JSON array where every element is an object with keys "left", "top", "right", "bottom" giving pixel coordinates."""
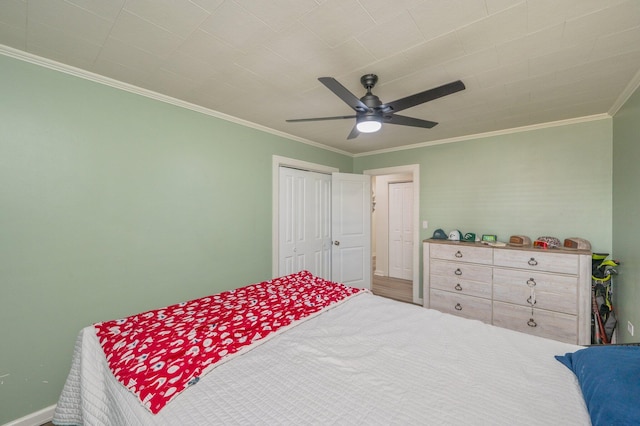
[{"left": 278, "top": 167, "right": 331, "bottom": 279}]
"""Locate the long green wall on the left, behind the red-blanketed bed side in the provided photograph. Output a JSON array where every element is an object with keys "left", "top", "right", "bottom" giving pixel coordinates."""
[{"left": 0, "top": 55, "right": 352, "bottom": 424}]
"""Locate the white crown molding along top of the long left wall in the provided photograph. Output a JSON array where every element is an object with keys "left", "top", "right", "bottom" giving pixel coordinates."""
[{"left": 0, "top": 44, "right": 353, "bottom": 157}]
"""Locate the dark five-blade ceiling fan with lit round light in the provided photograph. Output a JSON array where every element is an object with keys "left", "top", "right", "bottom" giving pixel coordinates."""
[{"left": 286, "top": 74, "right": 465, "bottom": 139}]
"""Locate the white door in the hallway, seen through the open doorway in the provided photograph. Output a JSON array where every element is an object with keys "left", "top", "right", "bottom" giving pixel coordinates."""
[{"left": 389, "top": 182, "right": 413, "bottom": 280}]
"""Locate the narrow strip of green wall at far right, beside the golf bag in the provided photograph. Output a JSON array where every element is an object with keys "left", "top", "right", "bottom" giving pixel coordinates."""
[{"left": 613, "top": 85, "right": 640, "bottom": 343}]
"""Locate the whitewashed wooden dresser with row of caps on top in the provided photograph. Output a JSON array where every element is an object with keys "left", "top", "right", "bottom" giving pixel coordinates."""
[{"left": 423, "top": 240, "right": 591, "bottom": 345}]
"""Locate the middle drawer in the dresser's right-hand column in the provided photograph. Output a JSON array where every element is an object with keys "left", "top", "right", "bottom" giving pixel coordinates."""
[{"left": 493, "top": 268, "right": 578, "bottom": 315}]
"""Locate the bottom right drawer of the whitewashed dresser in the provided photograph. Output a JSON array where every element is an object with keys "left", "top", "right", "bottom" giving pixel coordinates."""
[{"left": 493, "top": 301, "right": 578, "bottom": 344}]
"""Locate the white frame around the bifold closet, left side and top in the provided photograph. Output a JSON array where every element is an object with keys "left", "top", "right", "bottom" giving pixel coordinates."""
[{"left": 271, "top": 155, "right": 340, "bottom": 278}]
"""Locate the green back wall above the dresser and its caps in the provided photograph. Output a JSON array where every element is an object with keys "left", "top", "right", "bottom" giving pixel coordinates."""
[{"left": 354, "top": 119, "right": 612, "bottom": 252}]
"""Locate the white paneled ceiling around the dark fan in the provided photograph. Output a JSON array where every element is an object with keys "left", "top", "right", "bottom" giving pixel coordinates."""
[{"left": 0, "top": 0, "right": 640, "bottom": 154}]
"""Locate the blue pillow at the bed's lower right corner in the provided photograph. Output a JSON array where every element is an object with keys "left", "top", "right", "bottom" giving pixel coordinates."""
[{"left": 556, "top": 346, "right": 640, "bottom": 426}]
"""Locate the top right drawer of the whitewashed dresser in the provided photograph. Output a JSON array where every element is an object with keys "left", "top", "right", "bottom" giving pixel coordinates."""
[{"left": 493, "top": 249, "right": 579, "bottom": 275}]
